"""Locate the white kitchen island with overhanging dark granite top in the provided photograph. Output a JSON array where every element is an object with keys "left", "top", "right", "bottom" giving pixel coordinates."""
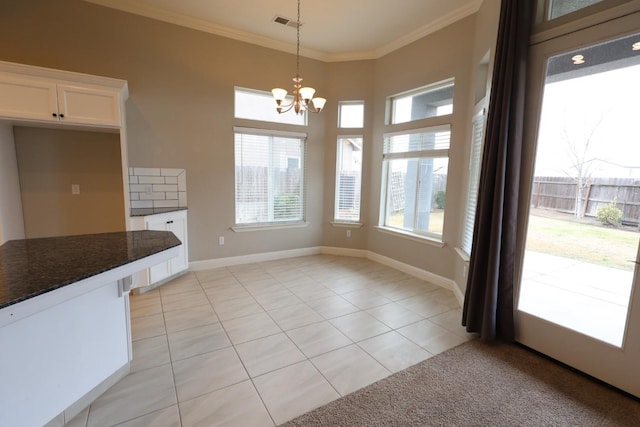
[{"left": 0, "top": 230, "right": 181, "bottom": 426}]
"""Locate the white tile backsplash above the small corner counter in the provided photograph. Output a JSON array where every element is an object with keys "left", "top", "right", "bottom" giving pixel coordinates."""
[{"left": 129, "top": 168, "right": 187, "bottom": 209}]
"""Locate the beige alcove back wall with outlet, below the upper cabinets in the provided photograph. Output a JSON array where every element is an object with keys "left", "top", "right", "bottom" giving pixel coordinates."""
[{"left": 13, "top": 127, "right": 125, "bottom": 238}]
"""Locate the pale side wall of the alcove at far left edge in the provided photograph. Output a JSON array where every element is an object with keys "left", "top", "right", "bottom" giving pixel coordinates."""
[{"left": 0, "top": 123, "right": 24, "bottom": 245}]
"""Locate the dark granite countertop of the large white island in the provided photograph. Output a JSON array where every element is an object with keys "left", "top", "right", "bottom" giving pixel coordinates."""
[{"left": 0, "top": 230, "right": 181, "bottom": 308}]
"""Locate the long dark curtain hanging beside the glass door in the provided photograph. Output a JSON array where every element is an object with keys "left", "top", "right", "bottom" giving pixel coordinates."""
[{"left": 462, "top": 0, "right": 533, "bottom": 341}]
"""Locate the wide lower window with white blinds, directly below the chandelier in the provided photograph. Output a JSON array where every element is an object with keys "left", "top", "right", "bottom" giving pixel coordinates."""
[{"left": 234, "top": 127, "right": 306, "bottom": 225}]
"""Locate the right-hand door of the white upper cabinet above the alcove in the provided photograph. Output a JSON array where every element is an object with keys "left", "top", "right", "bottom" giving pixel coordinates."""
[{"left": 58, "top": 84, "right": 120, "bottom": 126}]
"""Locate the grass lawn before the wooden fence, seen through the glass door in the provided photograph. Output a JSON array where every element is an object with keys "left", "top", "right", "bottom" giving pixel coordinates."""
[{"left": 527, "top": 215, "right": 640, "bottom": 271}]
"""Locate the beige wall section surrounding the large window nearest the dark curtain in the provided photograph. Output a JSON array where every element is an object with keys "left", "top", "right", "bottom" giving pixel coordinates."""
[{"left": 368, "top": 16, "right": 475, "bottom": 278}]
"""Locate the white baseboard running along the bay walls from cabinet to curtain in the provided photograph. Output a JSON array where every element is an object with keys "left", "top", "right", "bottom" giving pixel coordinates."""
[{"left": 189, "top": 246, "right": 464, "bottom": 305}]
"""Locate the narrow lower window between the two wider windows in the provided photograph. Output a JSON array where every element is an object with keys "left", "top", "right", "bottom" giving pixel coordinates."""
[{"left": 334, "top": 136, "right": 362, "bottom": 222}]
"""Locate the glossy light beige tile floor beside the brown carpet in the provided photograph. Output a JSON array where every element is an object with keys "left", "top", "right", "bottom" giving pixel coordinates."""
[{"left": 67, "top": 255, "right": 472, "bottom": 427}]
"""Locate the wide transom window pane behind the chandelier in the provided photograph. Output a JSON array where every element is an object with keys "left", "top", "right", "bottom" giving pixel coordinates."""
[{"left": 234, "top": 87, "right": 307, "bottom": 126}]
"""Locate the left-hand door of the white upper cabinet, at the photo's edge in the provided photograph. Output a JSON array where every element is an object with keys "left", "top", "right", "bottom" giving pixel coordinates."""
[{"left": 0, "top": 73, "right": 58, "bottom": 122}]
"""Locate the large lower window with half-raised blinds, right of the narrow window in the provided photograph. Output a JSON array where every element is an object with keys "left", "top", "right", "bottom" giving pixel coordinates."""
[{"left": 382, "top": 125, "right": 451, "bottom": 240}]
